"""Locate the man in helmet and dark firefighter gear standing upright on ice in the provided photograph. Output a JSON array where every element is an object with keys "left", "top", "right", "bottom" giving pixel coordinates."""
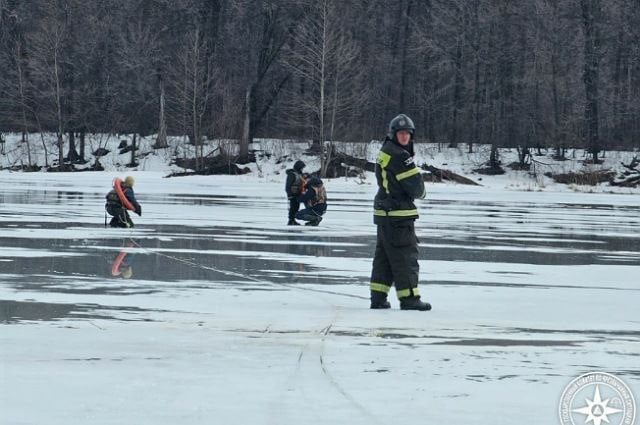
[{"left": 370, "top": 114, "right": 431, "bottom": 311}]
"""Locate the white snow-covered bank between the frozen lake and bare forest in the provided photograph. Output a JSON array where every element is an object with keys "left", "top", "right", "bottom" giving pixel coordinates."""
[{"left": 0, "top": 133, "right": 640, "bottom": 194}]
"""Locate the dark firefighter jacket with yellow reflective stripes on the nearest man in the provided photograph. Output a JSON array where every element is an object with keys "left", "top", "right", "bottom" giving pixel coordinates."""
[{"left": 373, "top": 139, "right": 426, "bottom": 224}]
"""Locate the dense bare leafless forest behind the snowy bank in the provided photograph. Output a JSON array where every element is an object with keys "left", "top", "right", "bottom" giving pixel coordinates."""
[{"left": 0, "top": 0, "right": 640, "bottom": 169}]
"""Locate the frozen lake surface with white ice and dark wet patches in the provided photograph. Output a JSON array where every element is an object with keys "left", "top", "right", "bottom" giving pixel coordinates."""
[{"left": 0, "top": 172, "right": 640, "bottom": 425}]
